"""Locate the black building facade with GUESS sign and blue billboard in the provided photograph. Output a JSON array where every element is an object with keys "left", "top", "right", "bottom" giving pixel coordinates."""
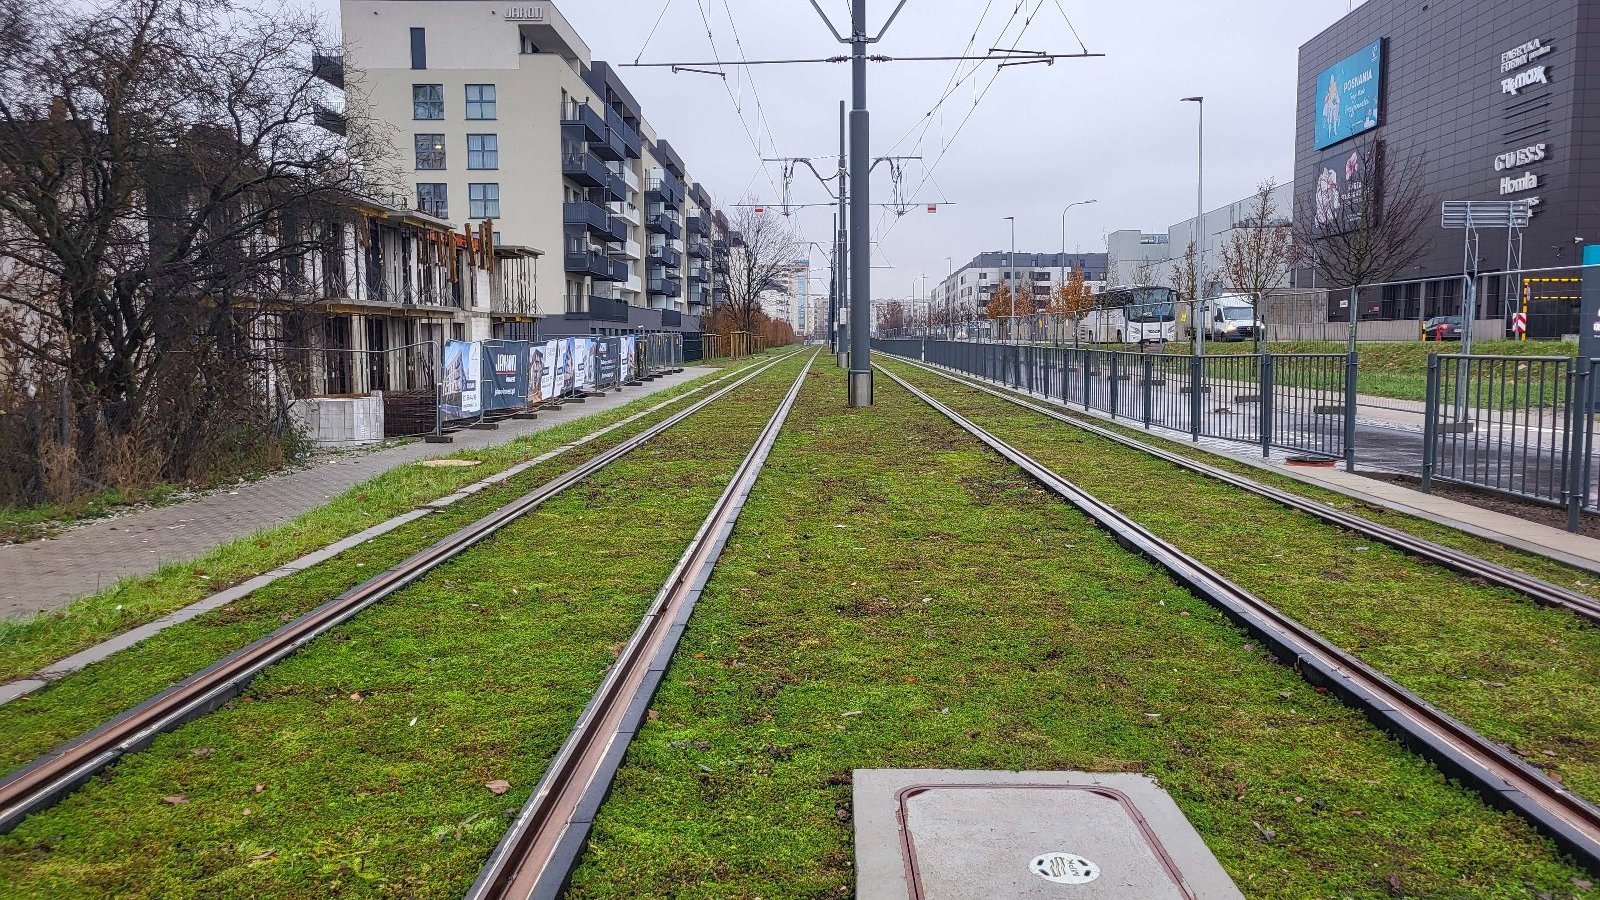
[{"left": 1294, "top": 0, "right": 1600, "bottom": 335}]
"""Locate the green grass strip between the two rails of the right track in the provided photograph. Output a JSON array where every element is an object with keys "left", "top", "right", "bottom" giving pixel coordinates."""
[{"left": 893, "top": 365, "right": 1600, "bottom": 798}]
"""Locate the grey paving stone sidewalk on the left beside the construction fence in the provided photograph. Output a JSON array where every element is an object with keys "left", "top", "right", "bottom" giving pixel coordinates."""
[{"left": 0, "top": 368, "right": 715, "bottom": 618}]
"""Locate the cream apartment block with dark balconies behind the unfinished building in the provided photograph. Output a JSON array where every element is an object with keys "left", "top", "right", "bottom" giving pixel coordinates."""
[{"left": 330, "top": 0, "right": 712, "bottom": 338}]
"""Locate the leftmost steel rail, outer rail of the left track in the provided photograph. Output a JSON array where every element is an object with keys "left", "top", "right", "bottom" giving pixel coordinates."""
[{"left": 0, "top": 351, "right": 803, "bottom": 834}]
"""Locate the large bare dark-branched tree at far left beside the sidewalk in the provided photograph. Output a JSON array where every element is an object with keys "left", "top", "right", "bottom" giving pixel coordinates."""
[{"left": 0, "top": 0, "right": 379, "bottom": 506}]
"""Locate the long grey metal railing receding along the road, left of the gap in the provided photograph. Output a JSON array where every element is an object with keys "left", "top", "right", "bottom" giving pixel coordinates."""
[{"left": 874, "top": 338, "right": 1355, "bottom": 458}]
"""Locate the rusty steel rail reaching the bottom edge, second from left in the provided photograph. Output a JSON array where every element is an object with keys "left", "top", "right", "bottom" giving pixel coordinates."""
[{"left": 467, "top": 352, "right": 816, "bottom": 900}]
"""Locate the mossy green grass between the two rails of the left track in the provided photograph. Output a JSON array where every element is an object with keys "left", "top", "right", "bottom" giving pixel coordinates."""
[{"left": 0, "top": 357, "right": 803, "bottom": 897}]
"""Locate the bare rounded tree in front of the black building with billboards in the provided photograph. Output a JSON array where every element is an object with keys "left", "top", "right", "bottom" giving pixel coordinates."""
[{"left": 1294, "top": 141, "right": 1434, "bottom": 352}]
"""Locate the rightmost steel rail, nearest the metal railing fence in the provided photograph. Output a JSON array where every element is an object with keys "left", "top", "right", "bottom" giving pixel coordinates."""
[{"left": 894, "top": 357, "right": 1600, "bottom": 625}]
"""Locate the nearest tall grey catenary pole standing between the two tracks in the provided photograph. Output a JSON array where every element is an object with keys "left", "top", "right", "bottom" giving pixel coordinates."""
[{"left": 848, "top": 0, "right": 872, "bottom": 408}]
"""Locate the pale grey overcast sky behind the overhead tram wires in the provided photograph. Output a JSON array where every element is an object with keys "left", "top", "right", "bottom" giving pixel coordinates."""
[{"left": 317, "top": 0, "right": 1350, "bottom": 296}]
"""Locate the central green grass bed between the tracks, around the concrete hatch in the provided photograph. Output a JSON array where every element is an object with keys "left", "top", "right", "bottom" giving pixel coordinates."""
[{"left": 570, "top": 372, "right": 1586, "bottom": 900}]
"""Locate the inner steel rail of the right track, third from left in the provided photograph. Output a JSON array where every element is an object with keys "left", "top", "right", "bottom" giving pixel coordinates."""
[{"left": 878, "top": 367, "right": 1600, "bottom": 871}]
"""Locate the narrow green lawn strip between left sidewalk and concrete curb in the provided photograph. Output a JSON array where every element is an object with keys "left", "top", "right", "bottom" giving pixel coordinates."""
[{"left": 0, "top": 350, "right": 780, "bottom": 681}]
